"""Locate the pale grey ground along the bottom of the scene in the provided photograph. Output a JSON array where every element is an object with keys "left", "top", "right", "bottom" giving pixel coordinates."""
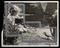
[{"left": 16, "top": 27, "right": 56, "bottom": 45}]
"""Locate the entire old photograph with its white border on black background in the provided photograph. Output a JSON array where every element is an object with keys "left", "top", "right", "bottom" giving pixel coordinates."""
[{"left": 1, "top": 1, "right": 59, "bottom": 47}]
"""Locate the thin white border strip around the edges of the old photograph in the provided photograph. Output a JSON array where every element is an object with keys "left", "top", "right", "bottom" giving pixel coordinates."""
[{"left": 1, "top": 1, "right": 59, "bottom": 47}]
